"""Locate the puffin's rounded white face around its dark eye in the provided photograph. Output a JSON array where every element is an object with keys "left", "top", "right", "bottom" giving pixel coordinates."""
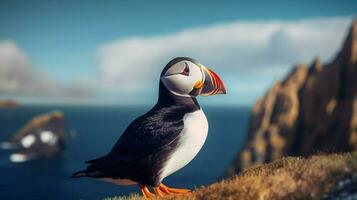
[{"left": 161, "top": 60, "right": 205, "bottom": 97}]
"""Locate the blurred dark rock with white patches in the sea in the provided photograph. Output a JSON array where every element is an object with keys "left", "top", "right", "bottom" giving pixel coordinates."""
[{"left": 7, "top": 111, "right": 64, "bottom": 162}]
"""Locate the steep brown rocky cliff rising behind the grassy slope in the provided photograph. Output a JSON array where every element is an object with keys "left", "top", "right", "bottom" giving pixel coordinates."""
[{"left": 228, "top": 19, "right": 357, "bottom": 174}]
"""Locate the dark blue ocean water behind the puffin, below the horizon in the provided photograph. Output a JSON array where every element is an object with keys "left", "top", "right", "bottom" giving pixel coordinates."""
[{"left": 0, "top": 106, "right": 249, "bottom": 200}]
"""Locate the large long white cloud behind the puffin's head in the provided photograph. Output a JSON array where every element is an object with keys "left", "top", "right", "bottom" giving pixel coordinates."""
[{"left": 99, "top": 17, "right": 352, "bottom": 103}]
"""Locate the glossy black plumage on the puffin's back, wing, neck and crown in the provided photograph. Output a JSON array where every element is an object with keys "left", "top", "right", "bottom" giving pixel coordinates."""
[{"left": 72, "top": 58, "right": 200, "bottom": 186}]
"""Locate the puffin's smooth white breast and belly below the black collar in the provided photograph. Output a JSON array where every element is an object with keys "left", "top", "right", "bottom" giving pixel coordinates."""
[{"left": 161, "top": 109, "right": 208, "bottom": 180}]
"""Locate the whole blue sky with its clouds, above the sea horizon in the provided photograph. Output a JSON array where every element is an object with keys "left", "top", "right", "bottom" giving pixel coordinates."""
[{"left": 0, "top": 0, "right": 357, "bottom": 105}]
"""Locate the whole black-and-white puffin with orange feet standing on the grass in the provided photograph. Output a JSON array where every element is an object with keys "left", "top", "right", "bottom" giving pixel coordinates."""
[{"left": 70, "top": 57, "right": 226, "bottom": 199}]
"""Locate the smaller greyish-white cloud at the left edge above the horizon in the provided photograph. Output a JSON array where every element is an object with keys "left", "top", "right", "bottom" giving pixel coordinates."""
[{"left": 0, "top": 40, "right": 88, "bottom": 102}]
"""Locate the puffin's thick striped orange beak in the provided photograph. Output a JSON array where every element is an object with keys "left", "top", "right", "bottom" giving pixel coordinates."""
[{"left": 200, "top": 66, "right": 226, "bottom": 96}]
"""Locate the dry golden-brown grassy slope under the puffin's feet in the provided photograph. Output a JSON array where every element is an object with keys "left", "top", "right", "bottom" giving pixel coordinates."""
[{"left": 108, "top": 152, "right": 357, "bottom": 200}]
